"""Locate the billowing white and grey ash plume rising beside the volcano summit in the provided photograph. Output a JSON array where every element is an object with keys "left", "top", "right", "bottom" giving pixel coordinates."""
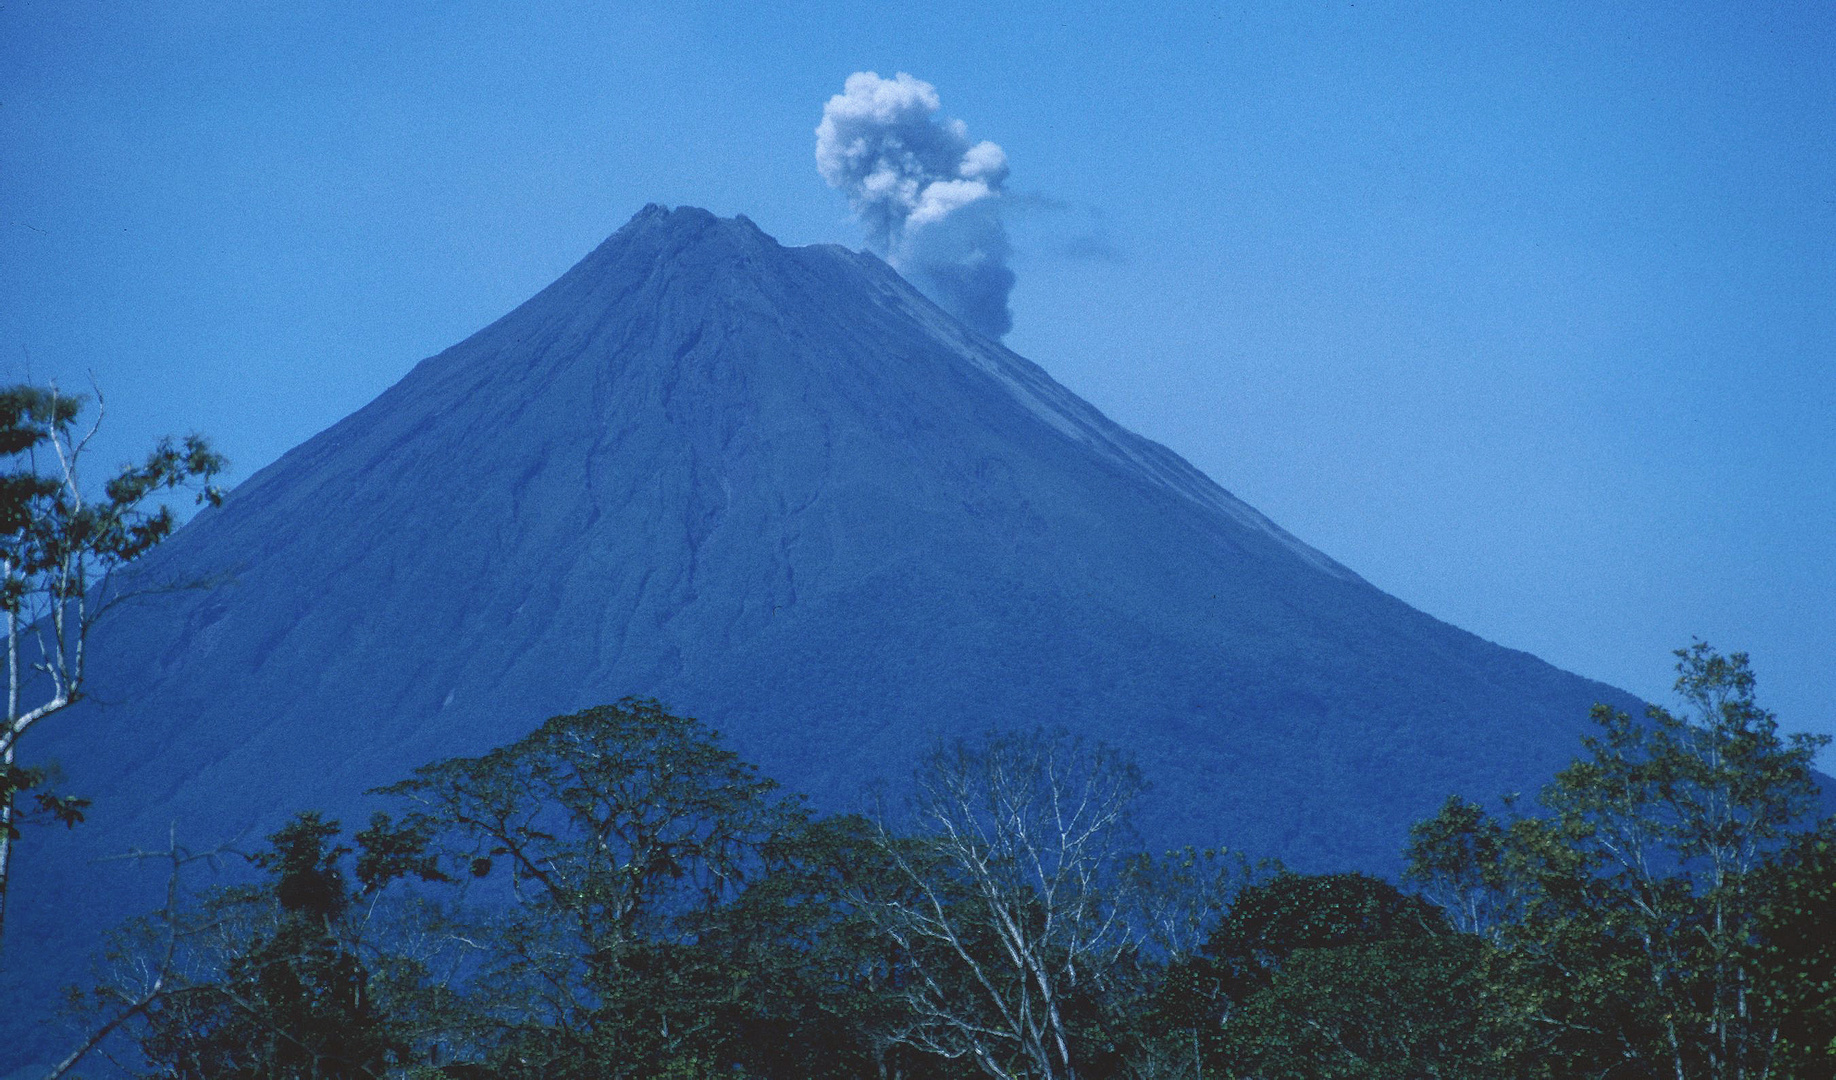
[{"left": 815, "top": 72, "right": 1013, "bottom": 338}]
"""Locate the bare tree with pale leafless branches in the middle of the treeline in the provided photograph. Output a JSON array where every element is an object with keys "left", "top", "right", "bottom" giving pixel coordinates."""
[{"left": 861, "top": 733, "right": 1144, "bottom": 1080}]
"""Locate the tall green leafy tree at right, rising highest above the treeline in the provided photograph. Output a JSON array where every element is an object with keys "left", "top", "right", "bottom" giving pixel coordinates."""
[{"left": 1408, "top": 641, "right": 1823, "bottom": 1080}]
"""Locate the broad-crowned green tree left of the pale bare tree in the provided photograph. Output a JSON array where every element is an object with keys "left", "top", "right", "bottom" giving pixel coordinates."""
[{"left": 374, "top": 700, "right": 804, "bottom": 1078}]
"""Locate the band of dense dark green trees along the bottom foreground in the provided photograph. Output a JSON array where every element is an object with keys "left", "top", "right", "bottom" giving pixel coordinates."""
[{"left": 57, "top": 643, "right": 1836, "bottom": 1080}]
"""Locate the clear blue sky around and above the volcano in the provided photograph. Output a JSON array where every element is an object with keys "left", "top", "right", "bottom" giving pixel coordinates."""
[{"left": 0, "top": 0, "right": 1836, "bottom": 768}]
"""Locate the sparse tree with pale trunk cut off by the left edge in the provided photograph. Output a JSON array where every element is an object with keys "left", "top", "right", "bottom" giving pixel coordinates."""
[{"left": 0, "top": 384, "right": 226, "bottom": 929}]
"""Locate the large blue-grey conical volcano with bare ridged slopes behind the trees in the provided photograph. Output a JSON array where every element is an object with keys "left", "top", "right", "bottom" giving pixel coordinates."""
[{"left": 7, "top": 206, "right": 1632, "bottom": 1035}]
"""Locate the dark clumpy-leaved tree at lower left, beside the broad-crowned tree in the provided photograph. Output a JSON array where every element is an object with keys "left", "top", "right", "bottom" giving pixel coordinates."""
[{"left": 85, "top": 812, "right": 451, "bottom": 1080}]
